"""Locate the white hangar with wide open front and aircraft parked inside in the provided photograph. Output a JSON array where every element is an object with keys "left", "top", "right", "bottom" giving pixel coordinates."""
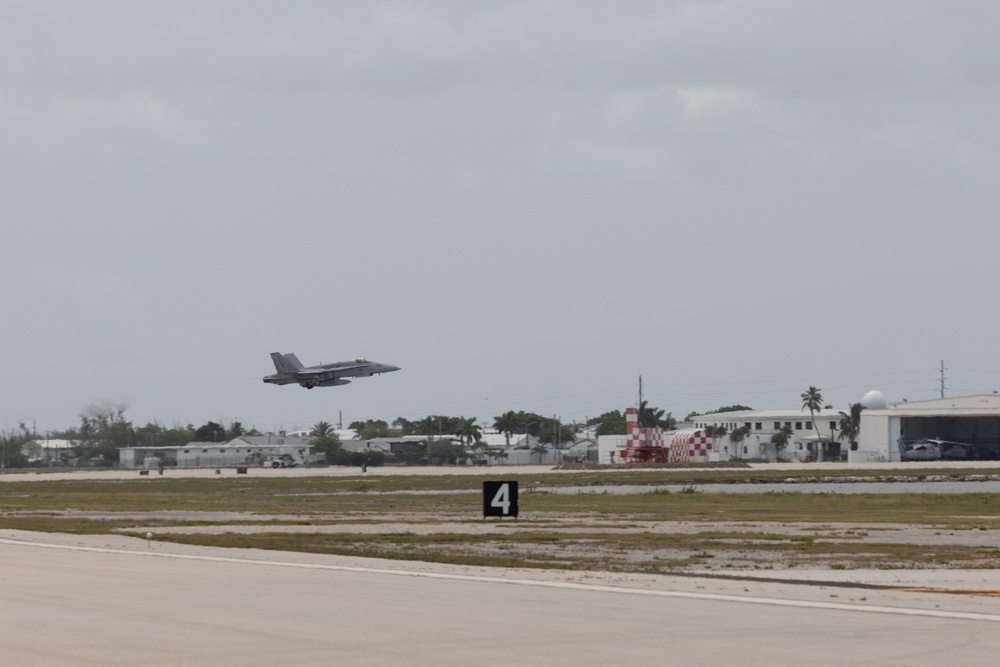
[{"left": 848, "top": 394, "right": 1000, "bottom": 463}]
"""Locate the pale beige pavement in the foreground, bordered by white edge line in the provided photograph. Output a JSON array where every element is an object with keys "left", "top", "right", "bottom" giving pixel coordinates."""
[{"left": 0, "top": 534, "right": 1000, "bottom": 667}]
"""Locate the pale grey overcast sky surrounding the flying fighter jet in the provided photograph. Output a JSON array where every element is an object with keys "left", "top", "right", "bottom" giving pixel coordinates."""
[{"left": 0, "top": 0, "right": 1000, "bottom": 431}]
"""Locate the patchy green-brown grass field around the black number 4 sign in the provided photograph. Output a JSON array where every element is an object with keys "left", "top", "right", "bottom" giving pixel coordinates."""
[{"left": 0, "top": 469, "right": 1000, "bottom": 572}]
